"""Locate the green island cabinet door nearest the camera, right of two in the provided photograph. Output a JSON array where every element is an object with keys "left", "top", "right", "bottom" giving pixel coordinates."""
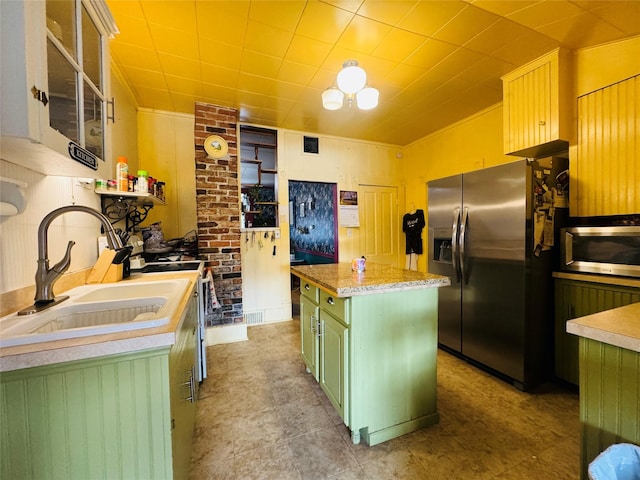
[{"left": 319, "top": 310, "right": 349, "bottom": 425}]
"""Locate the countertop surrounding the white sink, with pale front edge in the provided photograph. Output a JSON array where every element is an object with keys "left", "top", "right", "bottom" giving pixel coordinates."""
[{"left": 0, "top": 271, "right": 199, "bottom": 372}]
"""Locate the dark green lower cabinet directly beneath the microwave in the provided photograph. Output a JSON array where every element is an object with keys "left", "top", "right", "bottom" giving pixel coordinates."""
[{"left": 555, "top": 278, "right": 640, "bottom": 385}]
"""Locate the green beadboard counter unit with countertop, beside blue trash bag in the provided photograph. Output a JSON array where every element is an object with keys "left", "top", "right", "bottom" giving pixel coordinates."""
[{"left": 567, "top": 303, "right": 640, "bottom": 480}]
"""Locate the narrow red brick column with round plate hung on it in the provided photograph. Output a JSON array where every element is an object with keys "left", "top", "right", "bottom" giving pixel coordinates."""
[{"left": 194, "top": 102, "right": 243, "bottom": 326}]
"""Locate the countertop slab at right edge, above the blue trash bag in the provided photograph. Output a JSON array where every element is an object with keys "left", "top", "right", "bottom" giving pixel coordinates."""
[{"left": 567, "top": 303, "right": 640, "bottom": 353}]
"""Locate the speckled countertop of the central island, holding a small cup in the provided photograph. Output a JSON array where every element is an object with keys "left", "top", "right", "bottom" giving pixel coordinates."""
[{"left": 291, "top": 262, "right": 451, "bottom": 297}]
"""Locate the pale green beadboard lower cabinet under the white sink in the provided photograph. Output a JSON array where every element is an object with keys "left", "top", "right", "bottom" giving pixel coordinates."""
[{"left": 0, "top": 290, "right": 197, "bottom": 480}]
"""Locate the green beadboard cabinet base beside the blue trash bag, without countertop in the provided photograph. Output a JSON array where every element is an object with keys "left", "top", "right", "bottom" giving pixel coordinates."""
[{"left": 579, "top": 338, "right": 640, "bottom": 480}]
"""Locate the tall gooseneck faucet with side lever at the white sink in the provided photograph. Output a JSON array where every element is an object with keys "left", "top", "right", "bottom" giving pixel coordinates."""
[{"left": 18, "top": 205, "right": 123, "bottom": 315}]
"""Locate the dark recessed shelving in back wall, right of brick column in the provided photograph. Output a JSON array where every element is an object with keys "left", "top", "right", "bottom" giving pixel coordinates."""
[{"left": 240, "top": 125, "right": 278, "bottom": 228}]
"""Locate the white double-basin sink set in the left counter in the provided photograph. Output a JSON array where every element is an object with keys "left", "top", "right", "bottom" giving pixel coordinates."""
[{"left": 0, "top": 279, "right": 189, "bottom": 347}]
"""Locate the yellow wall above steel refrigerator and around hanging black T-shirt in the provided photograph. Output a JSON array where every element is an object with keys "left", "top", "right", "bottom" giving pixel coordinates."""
[{"left": 401, "top": 104, "right": 518, "bottom": 272}]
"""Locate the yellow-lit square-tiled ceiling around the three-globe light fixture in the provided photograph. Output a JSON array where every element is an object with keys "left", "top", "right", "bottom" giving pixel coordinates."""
[{"left": 107, "top": 0, "right": 640, "bottom": 145}]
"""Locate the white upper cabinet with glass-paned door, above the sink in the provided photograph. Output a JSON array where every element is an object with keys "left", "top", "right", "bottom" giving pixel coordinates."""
[{"left": 0, "top": 0, "right": 117, "bottom": 178}]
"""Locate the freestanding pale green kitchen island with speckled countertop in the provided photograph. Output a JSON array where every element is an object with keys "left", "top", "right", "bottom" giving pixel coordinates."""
[{"left": 291, "top": 263, "right": 450, "bottom": 445}]
